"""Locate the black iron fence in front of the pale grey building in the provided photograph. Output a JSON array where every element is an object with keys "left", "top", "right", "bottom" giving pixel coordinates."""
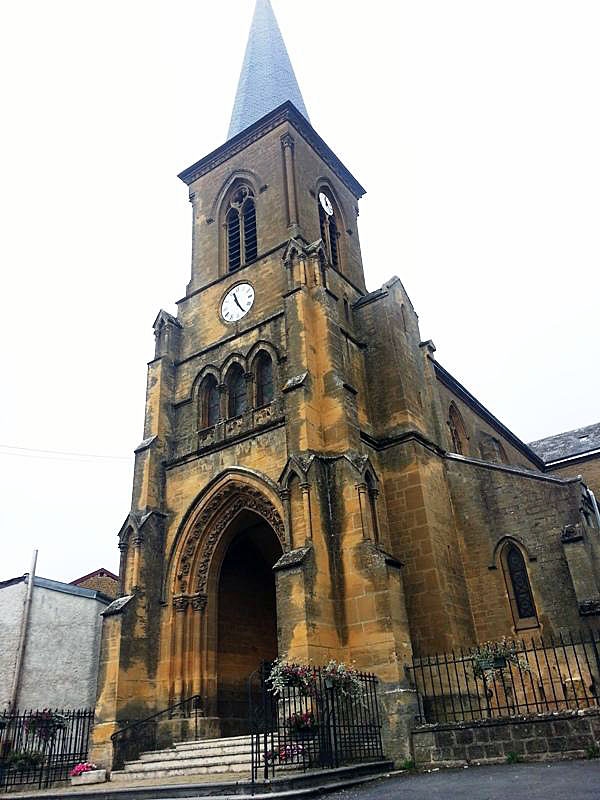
[{"left": 0, "top": 708, "right": 94, "bottom": 791}]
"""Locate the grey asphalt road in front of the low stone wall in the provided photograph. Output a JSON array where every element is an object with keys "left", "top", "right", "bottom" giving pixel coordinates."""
[{"left": 328, "top": 759, "right": 600, "bottom": 800}]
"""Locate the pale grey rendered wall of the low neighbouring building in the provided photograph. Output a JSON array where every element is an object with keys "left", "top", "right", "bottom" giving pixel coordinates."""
[{"left": 0, "top": 579, "right": 107, "bottom": 708}]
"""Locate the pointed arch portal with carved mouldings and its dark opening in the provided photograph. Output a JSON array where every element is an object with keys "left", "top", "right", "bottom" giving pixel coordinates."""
[{"left": 170, "top": 477, "right": 285, "bottom": 736}]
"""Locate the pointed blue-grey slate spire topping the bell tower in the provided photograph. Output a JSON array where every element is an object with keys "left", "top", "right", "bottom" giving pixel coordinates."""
[{"left": 227, "top": 0, "right": 308, "bottom": 139}]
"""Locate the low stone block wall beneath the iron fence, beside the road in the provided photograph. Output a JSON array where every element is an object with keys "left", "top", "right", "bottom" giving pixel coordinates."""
[{"left": 412, "top": 708, "right": 600, "bottom": 767}]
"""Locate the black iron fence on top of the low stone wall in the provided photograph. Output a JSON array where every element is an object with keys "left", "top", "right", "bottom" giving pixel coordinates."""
[{"left": 410, "top": 631, "right": 600, "bottom": 723}]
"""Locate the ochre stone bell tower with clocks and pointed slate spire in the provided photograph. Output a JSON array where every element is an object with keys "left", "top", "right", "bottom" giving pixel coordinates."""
[{"left": 94, "top": 0, "right": 418, "bottom": 772}]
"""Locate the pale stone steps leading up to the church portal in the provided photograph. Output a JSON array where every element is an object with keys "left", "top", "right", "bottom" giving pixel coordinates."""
[{"left": 110, "top": 736, "right": 252, "bottom": 783}]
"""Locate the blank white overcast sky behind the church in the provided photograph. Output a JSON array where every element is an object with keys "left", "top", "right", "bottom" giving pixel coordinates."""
[{"left": 0, "top": 0, "right": 600, "bottom": 581}]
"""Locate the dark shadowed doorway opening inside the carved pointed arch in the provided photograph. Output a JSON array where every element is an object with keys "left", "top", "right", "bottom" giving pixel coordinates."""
[{"left": 216, "top": 510, "right": 282, "bottom": 736}]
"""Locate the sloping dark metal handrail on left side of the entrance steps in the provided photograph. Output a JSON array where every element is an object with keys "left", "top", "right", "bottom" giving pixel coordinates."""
[{"left": 110, "top": 694, "right": 202, "bottom": 770}]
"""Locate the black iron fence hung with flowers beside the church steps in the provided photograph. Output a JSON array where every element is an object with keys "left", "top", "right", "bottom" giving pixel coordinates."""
[{"left": 249, "top": 663, "right": 384, "bottom": 782}]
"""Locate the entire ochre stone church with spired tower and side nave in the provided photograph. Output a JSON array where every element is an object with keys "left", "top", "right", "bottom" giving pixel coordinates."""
[{"left": 93, "top": 0, "right": 600, "bottom": 762}]
